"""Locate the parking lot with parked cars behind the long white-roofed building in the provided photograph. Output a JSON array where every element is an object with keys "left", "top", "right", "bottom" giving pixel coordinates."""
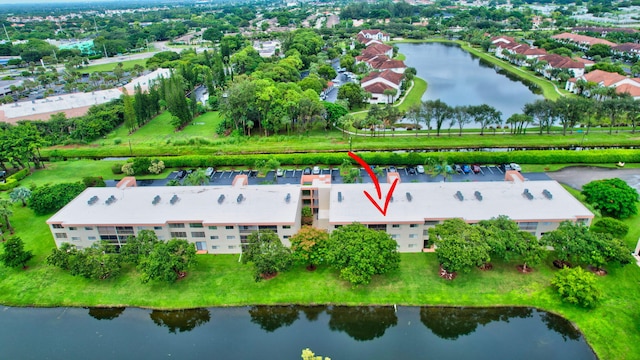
[{"left": 106, "top": 165, "right": 550, "bottom": 186}]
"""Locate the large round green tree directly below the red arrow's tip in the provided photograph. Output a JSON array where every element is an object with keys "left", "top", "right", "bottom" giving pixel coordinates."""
[{"left": 327, "top": 223, "right": 400, "bottom": 286}]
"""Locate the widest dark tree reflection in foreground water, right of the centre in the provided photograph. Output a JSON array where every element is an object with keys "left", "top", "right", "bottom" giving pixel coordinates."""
[{"left": 420, "top": 307, "right": 532, "bottom": 340}]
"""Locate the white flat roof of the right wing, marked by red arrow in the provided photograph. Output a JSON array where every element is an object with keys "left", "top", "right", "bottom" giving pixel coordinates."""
[{"left": 329, "top": 180, "right": 593, "bottom": 224}]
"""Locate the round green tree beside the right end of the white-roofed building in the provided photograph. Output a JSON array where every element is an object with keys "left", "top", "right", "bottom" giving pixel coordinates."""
[{"left": 582, "top": 178, "right": 638, "bottom": 219}]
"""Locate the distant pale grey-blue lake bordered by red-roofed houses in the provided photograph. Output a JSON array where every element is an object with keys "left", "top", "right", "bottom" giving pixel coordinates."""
[{"left": 397, "top": 43, "right": 544, "bottom": 120}]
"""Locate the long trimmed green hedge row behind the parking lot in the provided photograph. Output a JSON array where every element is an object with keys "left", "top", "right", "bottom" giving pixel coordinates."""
[{"left": 158, "top": 149, "right": 640, "bottom": 168}]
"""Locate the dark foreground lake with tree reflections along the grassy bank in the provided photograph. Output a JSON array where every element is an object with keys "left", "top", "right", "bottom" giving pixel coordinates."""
[{"left": 0, "top": 306, "right": 596, "bottom": 360}]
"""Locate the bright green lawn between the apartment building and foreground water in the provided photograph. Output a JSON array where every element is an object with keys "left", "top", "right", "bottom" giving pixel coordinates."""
[{"left": 0, "top": 202, "right": 640, "bottom": 360}]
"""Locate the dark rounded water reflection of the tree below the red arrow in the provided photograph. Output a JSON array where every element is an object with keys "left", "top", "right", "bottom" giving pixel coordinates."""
[{"left": 327, "top": 306, "right": 398, "bottom": 341}]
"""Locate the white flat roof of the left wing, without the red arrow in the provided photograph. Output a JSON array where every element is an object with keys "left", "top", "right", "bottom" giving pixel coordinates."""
[{"left": 47, "top": 185, "right": 300, "bottom": 226}]
